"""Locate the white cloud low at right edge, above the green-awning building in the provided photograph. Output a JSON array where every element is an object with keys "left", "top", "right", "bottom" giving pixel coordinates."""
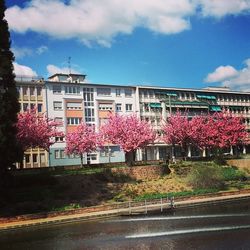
[{"left": 205, "top": 58, "right": 250, "bottom": 92}]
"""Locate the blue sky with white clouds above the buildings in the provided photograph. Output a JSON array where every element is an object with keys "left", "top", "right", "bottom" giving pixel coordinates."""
[{"left": 5, "top": 0, "right": 250, "bottom": 92}]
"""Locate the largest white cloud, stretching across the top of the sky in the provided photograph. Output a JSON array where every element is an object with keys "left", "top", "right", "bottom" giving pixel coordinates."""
[{"left": 6, "top": 0, "right": 195, "bottom": 46}]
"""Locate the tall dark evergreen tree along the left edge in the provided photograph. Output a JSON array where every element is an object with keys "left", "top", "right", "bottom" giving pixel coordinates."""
[{"left": 0, "top": 0, "right": 20, "bottom": 176}]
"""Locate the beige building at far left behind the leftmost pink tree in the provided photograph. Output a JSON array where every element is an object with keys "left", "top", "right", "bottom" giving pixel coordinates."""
[{"left": 16, "top": 76, "right": 48, "bottom": 168}]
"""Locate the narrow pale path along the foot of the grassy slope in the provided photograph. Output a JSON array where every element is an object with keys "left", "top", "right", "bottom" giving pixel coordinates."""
[{"left": 0, "top": 193, "right": 250, "bottom": 231}]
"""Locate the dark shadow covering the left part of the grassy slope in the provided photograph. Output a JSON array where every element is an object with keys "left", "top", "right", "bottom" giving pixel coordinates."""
[{"left": 0, "top": 169, "right": 131, "bottom": 217}]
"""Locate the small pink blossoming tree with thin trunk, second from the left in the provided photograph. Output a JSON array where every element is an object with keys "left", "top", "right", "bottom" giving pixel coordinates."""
[{"left": 65, "top": 123, "right": 102, "bottom": 167}]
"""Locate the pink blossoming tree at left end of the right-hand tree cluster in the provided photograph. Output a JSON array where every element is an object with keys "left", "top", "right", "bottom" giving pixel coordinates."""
[{"left": 162, "top": 111, "right": 192, "bottom": 157}]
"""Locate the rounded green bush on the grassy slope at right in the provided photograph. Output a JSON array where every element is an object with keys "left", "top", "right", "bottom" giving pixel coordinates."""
[{"left": 187, "top": 165, "right": 224, "bottom": 189}]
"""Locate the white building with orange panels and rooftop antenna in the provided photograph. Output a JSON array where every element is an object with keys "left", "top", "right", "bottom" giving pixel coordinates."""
[{"left": 45, "top": 74, "right": 137, "bottom": 166}]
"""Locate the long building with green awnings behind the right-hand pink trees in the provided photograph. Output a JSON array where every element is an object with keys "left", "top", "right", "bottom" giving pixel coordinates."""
[{"left": 137, "top": 86, "right": 250, "bottom": 160}]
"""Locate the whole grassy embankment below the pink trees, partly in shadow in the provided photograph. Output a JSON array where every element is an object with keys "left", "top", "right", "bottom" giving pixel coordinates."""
[{"left": 0, "top": 162, "right": 250, "bottom": 217}]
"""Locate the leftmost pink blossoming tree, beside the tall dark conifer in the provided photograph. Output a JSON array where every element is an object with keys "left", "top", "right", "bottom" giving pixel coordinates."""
[{"left": 17, "top": 108, "right": 64, "bottom": 151}]
